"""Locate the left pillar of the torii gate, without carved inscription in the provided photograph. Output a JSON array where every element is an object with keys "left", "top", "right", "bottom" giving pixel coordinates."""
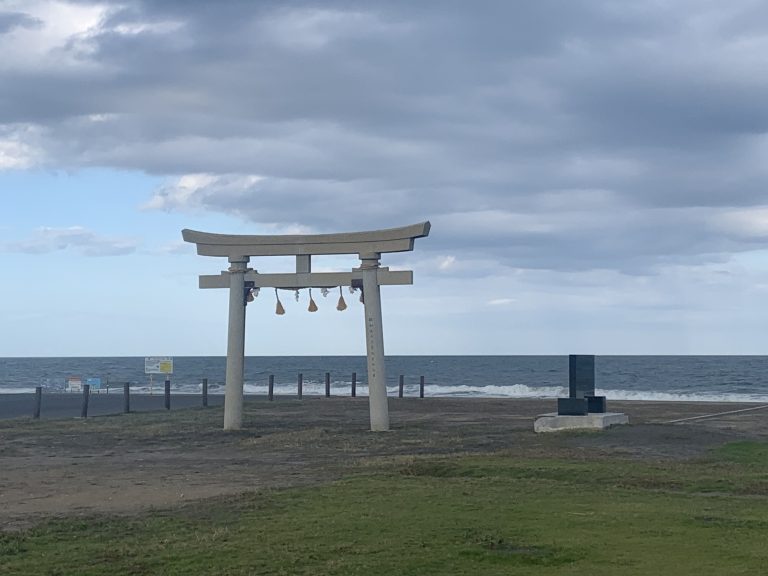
[{"left": 224, "top": 256, "right": 250, "bottom": 430}]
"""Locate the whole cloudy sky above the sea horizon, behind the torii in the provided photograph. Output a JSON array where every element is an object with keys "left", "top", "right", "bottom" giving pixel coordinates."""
[{"left": 0, "top": 0, "right": 768, "bottom": 356}]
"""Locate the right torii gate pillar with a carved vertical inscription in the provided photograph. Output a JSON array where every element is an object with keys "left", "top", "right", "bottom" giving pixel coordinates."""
[{"left": 360, "top": 252, "right": 389, "bottom": 432}]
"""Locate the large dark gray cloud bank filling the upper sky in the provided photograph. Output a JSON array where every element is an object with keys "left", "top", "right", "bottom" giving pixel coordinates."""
[{"left": 0, "top": 0, "right": 768, "bottom": 274}]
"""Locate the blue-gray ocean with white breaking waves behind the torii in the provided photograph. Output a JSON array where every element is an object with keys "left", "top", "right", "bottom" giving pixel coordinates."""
[{"left": 0, "top": 356, "right": 768, "bottom": 402}]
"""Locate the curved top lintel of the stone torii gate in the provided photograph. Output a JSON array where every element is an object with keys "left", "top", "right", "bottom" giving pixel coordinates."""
[{"left": 181, "top": 222, "right": 430, "bottom": 258}]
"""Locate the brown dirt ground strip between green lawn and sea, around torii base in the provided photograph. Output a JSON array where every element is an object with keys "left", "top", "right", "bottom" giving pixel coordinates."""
[{"left": 0, "top": 398, "right": 768, "bottom": 530}]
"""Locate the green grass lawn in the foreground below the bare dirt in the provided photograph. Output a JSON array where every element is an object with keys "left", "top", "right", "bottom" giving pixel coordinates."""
[{"left": 0, "top": 442, "right": 768, "bottom": 576}]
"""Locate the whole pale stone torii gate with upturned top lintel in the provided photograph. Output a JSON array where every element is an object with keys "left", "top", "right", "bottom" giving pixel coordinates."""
[{"left": 181, "top": 222, "right": 430, "bottom": 431}]
